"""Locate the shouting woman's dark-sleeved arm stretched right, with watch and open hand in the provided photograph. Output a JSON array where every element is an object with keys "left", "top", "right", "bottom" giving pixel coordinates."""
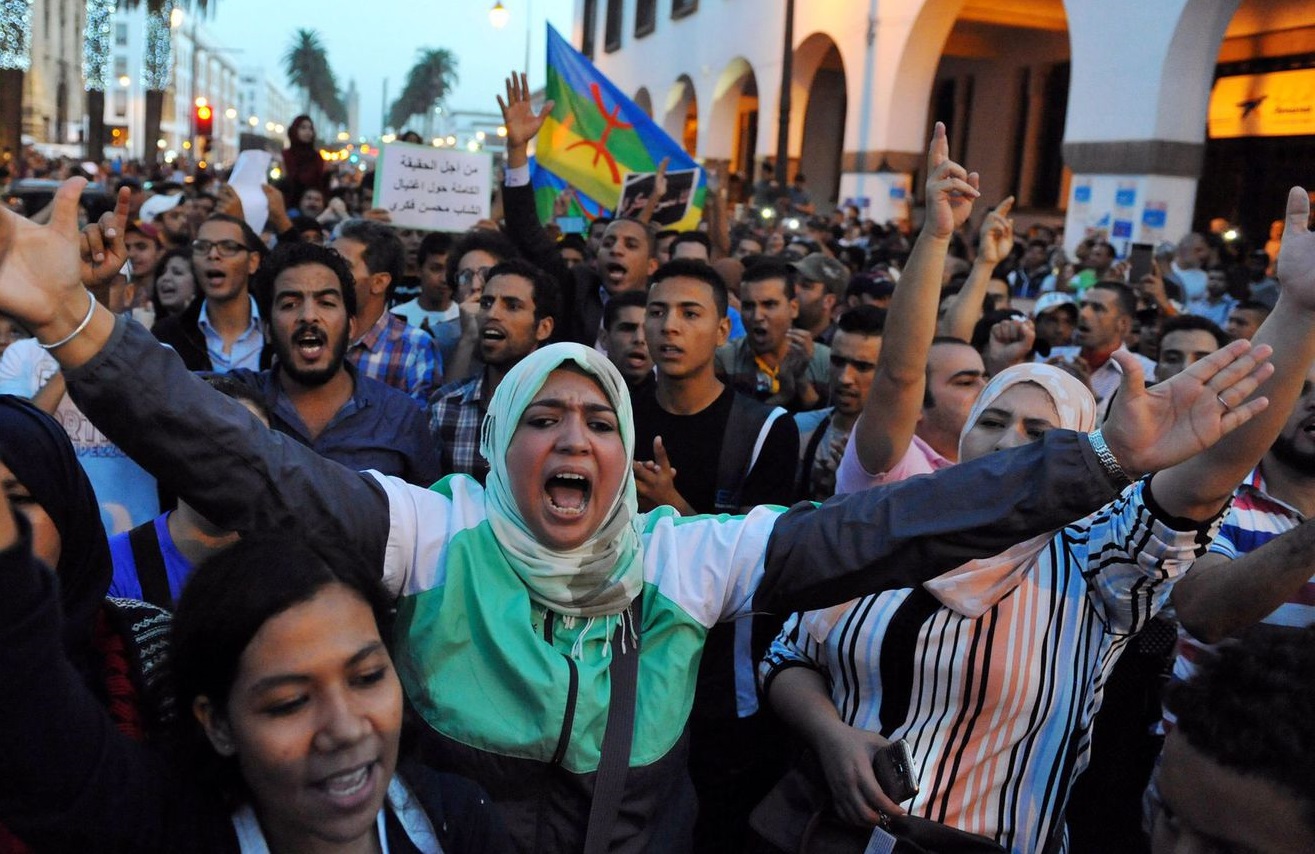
[{"left": 753, "top": 341, "right": 1269, "bottom": 611}]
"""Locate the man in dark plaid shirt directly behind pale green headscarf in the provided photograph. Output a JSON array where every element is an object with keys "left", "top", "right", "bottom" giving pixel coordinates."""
[{"left": 429, "top": 258, "right": 558, "bottom": 483}]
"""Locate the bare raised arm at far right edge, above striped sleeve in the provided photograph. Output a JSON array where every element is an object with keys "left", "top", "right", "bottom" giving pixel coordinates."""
[{"left": 1146, "top": 187, "right": 1315, "bottom": 521}]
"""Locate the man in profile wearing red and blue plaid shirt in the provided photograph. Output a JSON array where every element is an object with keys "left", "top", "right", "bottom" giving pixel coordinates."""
[{"left": 333, "top": 220, "right": 443, "bottom": 405}]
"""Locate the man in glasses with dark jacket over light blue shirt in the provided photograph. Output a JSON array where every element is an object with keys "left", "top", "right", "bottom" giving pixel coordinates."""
[{"left": 147, "top": 211, "right": 272, "bottom": 374}]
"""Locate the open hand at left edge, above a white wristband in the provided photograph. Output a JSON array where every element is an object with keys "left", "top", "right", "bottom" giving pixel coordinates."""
[{"left": 0, "top": 178, "right": 90, "bottom": 332}]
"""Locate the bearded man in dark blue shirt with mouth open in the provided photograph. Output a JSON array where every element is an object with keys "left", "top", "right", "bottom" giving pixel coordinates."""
[{"left": 229, "top": 242, "right": 433, "bottom": 486}]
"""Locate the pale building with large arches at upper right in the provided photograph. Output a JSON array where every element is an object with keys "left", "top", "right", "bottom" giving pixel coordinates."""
[{"left": 581, "top": 0, "right": 1315, "bottom": 251}]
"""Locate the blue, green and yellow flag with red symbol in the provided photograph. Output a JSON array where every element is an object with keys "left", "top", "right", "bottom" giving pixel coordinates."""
[{"left": 535, "top": 25, "right": 705, "bottom": 230}]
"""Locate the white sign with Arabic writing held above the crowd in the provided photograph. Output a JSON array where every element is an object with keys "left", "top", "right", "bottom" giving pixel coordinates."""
[{"left": 375, "top": 142, "right": 493, "bottom": 232}]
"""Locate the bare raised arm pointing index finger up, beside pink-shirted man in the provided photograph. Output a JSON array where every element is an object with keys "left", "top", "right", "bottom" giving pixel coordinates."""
[{"left": 851, "top": 121, "right": 978, "bottom": 474}]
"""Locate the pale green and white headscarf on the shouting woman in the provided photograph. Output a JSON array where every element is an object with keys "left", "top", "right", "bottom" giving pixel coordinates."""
[{"left": 480, "top": 343, "right": 643, "bottom": 617}]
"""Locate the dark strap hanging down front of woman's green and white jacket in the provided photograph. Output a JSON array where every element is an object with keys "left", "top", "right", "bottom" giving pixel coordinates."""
[{"left": 584, "top": 592, "right": 644, "bottom": 854}]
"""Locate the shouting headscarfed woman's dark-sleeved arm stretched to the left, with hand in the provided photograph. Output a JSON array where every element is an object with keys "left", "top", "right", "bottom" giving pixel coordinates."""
[{"left": 0, "top": 179, "right": 389, "bottom": 567}]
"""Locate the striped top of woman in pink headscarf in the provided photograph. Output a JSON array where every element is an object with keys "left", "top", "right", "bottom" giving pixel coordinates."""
[{"left": 760, "top": 482, "right": 1219, "bottom": 854}]
